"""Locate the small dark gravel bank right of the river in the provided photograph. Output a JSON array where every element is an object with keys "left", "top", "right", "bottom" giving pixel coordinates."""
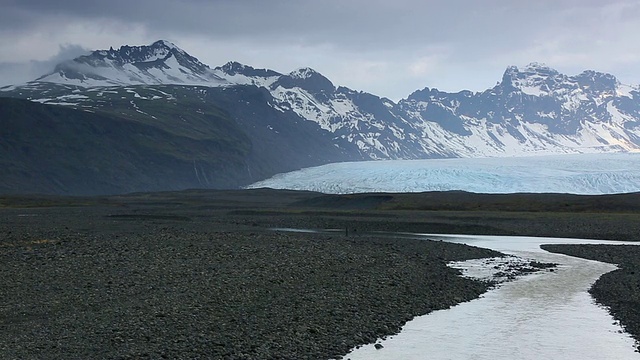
[{"left": 542, "top": 245, "right": 640, "bottom": 352}]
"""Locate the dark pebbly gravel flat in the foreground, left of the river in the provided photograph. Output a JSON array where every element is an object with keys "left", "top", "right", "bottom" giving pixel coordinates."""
[{"left": 0, "top": 207, "right": 498, "bottom": 359}]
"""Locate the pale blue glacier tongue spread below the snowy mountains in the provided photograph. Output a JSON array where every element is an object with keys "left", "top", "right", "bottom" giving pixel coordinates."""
[{"left": 248, "top": 153, "right": 640, "bottom": 195}]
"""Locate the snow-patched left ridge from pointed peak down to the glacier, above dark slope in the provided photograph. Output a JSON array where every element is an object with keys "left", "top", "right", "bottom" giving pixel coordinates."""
[{"left": 0, "top": 40, "right": 432, "bottom": 159}]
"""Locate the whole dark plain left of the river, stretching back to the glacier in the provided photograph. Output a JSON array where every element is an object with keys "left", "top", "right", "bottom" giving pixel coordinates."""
[{"left": 0, "top": 190, "right": 640, "bottom": 359}]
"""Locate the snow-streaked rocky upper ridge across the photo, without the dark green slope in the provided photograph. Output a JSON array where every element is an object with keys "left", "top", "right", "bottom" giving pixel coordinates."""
[{"left": 0, "top": 41, "right": 640, "bottom": 159}]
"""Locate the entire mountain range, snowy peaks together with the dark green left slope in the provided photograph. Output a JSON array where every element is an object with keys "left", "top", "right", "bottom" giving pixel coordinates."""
[{"left": 0, "top": 40, "right": 640, "bottom": 194}]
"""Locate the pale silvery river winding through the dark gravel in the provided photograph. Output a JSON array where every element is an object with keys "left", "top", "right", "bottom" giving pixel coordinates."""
[{"left": 345, "top": 235, "right": 640, "bottom": 360}]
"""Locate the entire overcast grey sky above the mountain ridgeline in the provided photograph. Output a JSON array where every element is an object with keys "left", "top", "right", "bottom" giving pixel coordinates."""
[{"left": 0, "top": 0, "right": 640, "bottom": 100}]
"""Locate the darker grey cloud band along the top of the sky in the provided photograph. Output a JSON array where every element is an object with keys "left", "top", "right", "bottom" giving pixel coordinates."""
[{"left": 0, "top": 0, "right": 573, "bottom": 50}]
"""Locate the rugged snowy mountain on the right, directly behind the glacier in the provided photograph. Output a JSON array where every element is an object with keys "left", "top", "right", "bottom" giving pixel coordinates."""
[{"left": 397, "top": 63, "right": 640, "bottom": 157}]
